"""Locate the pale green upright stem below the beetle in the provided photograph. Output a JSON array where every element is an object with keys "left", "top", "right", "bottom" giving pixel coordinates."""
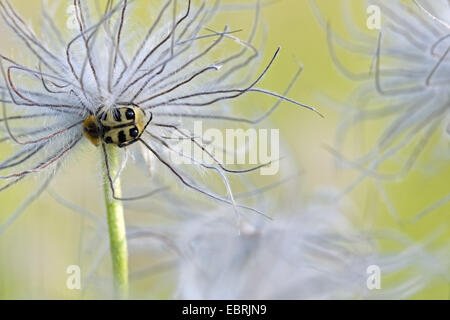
[{"left": 103, "top": 146, "right": 128, "bottom": 299}]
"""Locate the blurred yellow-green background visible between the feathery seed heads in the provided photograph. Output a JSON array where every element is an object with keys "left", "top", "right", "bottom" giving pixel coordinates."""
[{"left": 0, "top": 0, "right": 450, "bottom": 299}]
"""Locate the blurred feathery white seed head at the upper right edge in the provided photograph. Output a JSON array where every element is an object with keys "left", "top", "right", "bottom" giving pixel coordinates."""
[{"left": 310, "top": 0, "right": 450, "bottom": 222}]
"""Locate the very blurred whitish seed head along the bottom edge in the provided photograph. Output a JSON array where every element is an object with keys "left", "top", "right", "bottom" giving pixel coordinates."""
[{"left": 167, "top": 201, "right": 449, "bottom": 299}]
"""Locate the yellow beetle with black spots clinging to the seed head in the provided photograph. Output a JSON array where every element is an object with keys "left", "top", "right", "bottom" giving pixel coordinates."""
[{"left": 83, "top": 104, "right": 152, "bottom": 148}]
